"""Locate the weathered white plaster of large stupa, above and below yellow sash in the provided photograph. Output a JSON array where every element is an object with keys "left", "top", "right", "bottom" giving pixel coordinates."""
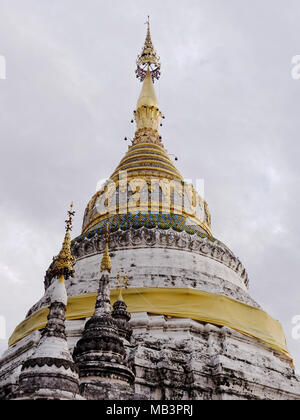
[{"left": 0, "top": 229, "right": 300, "bottom": 399}]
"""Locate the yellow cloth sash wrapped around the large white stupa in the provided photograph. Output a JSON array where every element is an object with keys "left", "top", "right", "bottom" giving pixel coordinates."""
[{"left": 9, "top": 288, "right": 292, "bottom": 360}]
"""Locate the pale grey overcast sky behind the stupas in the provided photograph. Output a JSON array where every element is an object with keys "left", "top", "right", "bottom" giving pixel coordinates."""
[{"left": 0, "top": 0, "right": 300, "bottom": 370}]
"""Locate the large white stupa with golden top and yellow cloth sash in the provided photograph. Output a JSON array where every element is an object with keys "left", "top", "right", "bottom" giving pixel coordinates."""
[{"left": 0, "top": 21, "right": 300, "bottom": 400}]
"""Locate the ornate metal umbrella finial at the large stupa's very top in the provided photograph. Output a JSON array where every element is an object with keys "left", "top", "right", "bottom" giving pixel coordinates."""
[{"left": 135, "top": 16, "right": 160, "bottom": 82}]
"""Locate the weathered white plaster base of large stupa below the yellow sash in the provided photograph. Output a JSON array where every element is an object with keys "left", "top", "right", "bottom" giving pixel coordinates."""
[{"left": 0, "top": 313, "right": 300, "bottom": 399}]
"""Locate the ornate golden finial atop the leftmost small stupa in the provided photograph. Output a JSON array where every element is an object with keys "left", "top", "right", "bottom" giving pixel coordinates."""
[{"left": 49, "top": 203, "right": 76, "bottom": 282}]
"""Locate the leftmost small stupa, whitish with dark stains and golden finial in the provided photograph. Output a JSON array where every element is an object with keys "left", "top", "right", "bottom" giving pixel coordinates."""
[{"left": 15, "top": 203, "right": 82, "bottom": 400}]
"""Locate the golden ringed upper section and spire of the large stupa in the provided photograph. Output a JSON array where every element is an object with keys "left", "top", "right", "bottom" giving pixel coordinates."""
[{"left": 82, "top": 21, "right": 211, "bottom": 235}]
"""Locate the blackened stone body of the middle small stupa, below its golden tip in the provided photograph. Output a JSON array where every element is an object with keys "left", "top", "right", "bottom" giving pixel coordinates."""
[{"left": 73, "top": 275, "right": 135, "bottom": 399}]
